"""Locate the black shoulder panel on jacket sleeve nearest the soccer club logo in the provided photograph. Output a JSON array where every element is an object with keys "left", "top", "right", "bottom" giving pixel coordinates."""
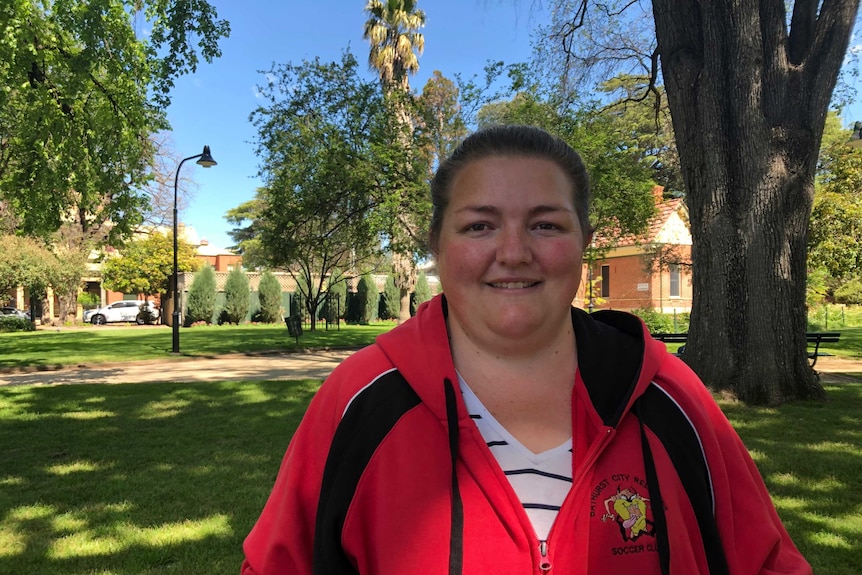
[{"left": 634, "top": 384, "right": 728, "bottom": 575}]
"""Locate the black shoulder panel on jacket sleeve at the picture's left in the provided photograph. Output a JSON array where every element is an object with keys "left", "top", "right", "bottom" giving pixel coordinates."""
[{"left": 314, "top": 371, "right": 420, "bottom": 575}]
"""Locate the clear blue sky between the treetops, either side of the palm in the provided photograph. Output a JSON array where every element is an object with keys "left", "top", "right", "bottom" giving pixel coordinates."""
[{"left": 168, "top": 0, "right": 547, "bottom": 247}]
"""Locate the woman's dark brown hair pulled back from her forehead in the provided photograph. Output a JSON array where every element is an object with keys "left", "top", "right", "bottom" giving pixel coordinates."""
[{"left": 428, "top": 125, "right": 592, "bottom": 251}]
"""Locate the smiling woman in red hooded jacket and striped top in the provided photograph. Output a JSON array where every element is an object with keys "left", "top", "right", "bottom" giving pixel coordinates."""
[{"left": 243, "top": 126, "right": 810, "bottom": 575}]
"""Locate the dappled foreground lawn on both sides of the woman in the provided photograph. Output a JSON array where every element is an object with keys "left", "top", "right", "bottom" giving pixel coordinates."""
[{"left": 0, "top": 378, "right": 862, "bottom": 575}]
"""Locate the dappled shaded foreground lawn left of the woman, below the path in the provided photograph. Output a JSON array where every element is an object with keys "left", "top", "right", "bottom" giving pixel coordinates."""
[{"left": 0, "top": 381, "right": 318, "bottom": 575}]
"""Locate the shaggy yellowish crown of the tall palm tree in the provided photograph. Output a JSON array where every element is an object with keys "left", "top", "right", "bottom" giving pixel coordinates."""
[{"left": 362, "top": 0, "right": 425, "bottom": 91}]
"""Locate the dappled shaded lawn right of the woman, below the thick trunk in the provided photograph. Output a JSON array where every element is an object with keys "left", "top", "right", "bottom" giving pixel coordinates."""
[{"left": 721, "top": 380, "right": 862, "bottom": 575}]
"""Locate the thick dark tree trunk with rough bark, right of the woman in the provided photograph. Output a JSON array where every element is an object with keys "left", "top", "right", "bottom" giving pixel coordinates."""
[{"left": 653, "top": 0, "right": 859, "bottom": 404}]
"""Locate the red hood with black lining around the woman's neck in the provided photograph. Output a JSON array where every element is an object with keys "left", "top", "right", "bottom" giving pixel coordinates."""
[{"left": 377, "top": 294, "right": 666, "bottom": 427}]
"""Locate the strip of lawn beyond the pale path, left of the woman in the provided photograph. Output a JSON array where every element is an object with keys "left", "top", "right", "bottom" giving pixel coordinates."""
[{"left": 0, "top": 322, "right": 395, "bottom": 368}]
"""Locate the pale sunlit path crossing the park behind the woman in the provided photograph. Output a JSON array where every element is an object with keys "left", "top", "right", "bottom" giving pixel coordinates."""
[{"left": 0, "top": 350, "right": 862, "bottom": 387}]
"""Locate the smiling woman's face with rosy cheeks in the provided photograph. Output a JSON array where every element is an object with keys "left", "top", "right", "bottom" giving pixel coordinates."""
[{"left": 436, "top": 156, "right": 584, "bottom": 343}]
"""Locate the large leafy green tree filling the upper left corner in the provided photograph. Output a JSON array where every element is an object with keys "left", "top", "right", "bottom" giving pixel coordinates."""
[{"left": 0, "top": 0, "right": 230, "bottom": 238}]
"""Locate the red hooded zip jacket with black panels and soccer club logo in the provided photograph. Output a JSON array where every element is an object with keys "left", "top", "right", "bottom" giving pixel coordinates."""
[{"left": 242, "top": 296, "right": 811, "bottom": 575}]
